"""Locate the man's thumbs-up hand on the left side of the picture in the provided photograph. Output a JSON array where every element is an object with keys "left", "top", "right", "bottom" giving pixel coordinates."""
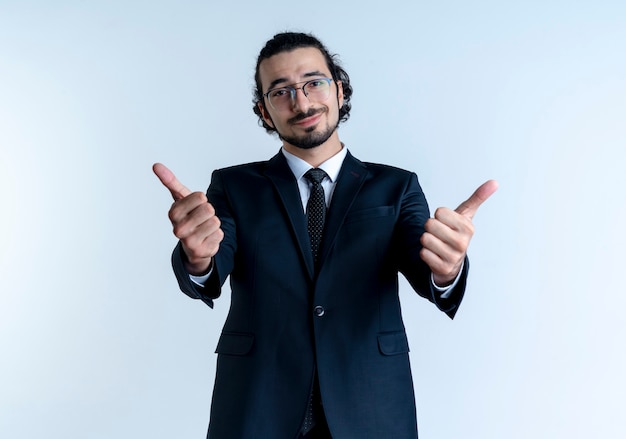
[{"left": 152, "top": 163, "right": 224, "bottom": 276}]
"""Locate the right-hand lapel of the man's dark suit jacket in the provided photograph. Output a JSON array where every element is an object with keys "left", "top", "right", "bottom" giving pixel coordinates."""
[{"left": 320, "top": 152, "right": 368, "bottom": 266}]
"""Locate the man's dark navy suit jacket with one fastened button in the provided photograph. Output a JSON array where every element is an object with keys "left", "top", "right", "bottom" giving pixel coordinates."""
[{"left": 172, "top": 153, "right": 469, "bottom": 439}]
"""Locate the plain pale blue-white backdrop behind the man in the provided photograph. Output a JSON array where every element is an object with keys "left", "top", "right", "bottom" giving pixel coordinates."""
[{"left": 0, "top": 0, "right": 626, "bottom": 439}]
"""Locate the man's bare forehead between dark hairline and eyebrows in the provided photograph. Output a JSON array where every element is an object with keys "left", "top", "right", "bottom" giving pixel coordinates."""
[{"left": 259, "top": 47, "right": 330, "bottom": 90}]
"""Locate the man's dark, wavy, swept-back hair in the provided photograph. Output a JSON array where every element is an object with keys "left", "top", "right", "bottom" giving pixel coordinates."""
[{"left": 252, "top": 32, "right": 352, "bottom": 133}]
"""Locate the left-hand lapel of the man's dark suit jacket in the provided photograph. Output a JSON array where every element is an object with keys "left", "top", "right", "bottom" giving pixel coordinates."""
[{"left": 265, "top": 152, "right": 315, "bottom": 278}]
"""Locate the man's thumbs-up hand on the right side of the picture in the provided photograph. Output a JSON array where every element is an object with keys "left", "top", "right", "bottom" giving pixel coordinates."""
[{"left": 420, "top": 180, "right": 498, "bottom": 287}]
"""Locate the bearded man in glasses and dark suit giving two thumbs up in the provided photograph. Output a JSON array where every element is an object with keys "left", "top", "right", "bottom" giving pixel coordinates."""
[{"left": 154, "top": 33, "right": 497, "bottom": 439}]
